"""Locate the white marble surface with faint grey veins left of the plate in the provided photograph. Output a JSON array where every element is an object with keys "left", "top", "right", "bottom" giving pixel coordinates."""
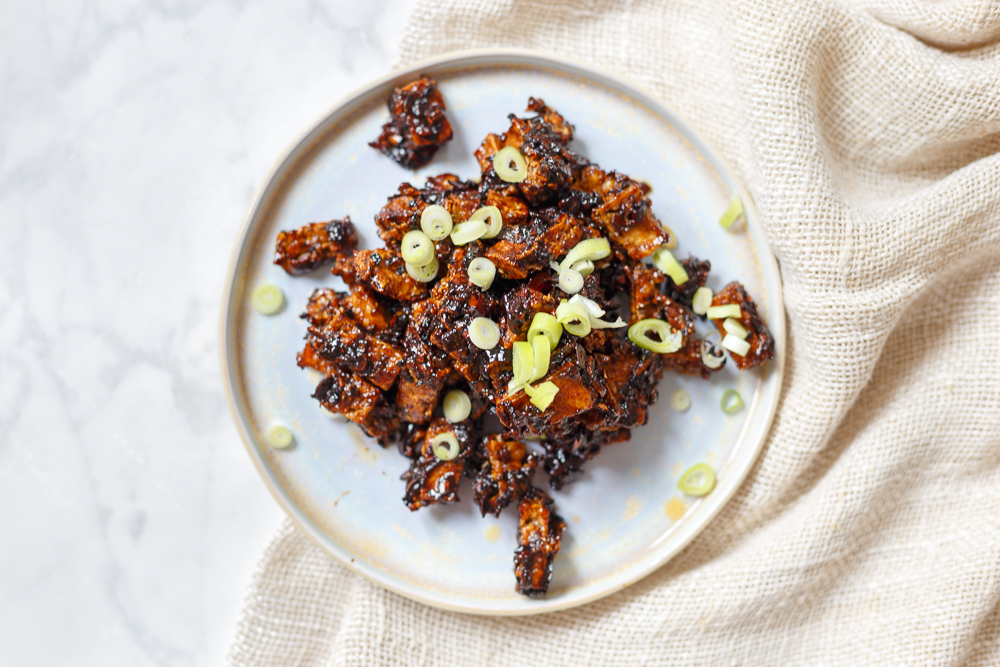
[{"left": 0, "top": 0, "right": 412, "bottom": 667}]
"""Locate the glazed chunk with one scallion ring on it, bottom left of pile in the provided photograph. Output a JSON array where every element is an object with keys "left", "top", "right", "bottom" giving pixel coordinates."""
[{"left": 402, "top": 417, "right": 472, "bottom": 512}]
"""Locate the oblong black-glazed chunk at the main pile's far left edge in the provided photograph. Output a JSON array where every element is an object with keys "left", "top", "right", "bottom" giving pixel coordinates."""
[{"left": 309, "top": 310, "right": 403, "bottom": 391}]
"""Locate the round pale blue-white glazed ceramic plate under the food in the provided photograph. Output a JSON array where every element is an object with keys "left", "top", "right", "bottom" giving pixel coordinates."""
[{"left": 222, "top": 51, "right": 785, "bottom": 615}]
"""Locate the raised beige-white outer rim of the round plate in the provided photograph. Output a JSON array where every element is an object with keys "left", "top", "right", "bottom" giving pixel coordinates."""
[{"left": 220, "top": 49, "right": 786, "bottom": 616}]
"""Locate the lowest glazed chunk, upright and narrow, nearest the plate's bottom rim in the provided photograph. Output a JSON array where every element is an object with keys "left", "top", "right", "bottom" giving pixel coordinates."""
[{"left": 514, "top": 487, "right": 566, "bottom": 598}]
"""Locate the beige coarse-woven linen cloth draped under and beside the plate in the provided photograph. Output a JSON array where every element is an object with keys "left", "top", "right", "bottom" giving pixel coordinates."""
[{"left": 231, "top": 0, "right": 1000, "bottom": 666}]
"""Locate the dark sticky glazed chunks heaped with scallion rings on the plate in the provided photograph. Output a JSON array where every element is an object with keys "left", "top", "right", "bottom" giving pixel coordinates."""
[{"left": 275, "top": 78, "right": 774, "bottom": 597}]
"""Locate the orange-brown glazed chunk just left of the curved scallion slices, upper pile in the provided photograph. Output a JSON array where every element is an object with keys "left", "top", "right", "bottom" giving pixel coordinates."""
[{"left": 485, "top": 213, "right": 581, "bottom": 279}]
